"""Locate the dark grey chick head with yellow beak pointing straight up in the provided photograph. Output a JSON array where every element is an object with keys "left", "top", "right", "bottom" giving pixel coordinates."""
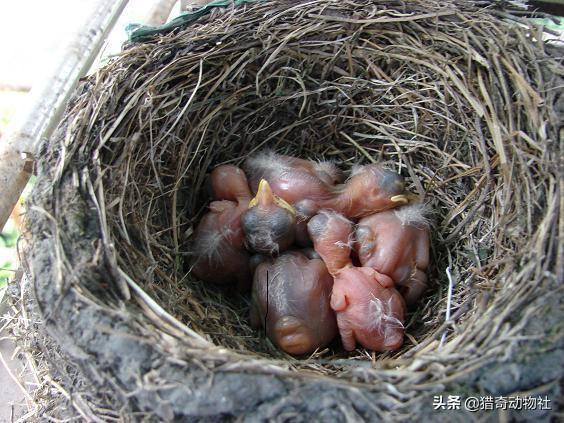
[{"left": 241, "top": 179, "right": 296, "bottom": 255}]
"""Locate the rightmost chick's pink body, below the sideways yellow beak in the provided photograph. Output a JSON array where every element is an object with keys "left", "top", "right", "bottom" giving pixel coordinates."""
[{"left": 355, "top": 206, "right": 429, "bottom": 306}]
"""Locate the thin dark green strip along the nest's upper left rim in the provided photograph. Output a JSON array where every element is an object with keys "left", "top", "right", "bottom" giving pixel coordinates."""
[{"left": 125, "top": 0, "right": 264, "bottom": 41}]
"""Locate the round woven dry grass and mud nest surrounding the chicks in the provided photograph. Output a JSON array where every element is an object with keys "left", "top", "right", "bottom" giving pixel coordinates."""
[{"left": 24, "top": 0, "right": 564, "bottom": 421}]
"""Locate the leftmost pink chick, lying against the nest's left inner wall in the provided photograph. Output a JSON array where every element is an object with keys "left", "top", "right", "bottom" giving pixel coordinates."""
[{"left": 192, "top": 165, "right": 252, "bottom": 291}]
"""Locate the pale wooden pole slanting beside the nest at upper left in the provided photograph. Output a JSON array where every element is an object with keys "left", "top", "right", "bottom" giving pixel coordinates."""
[{"left": 0, "top": 0, "right": 128, "bottom": 229}]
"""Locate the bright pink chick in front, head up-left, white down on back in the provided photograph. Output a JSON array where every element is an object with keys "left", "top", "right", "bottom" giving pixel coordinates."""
[{"left": 308, "top": 211, "right": 405, "bottom": 351}]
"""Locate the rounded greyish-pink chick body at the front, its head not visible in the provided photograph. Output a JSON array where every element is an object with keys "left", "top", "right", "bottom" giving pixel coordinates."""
[{"left": 251, "top": 251, "right": 337, "bottom": 355}]
